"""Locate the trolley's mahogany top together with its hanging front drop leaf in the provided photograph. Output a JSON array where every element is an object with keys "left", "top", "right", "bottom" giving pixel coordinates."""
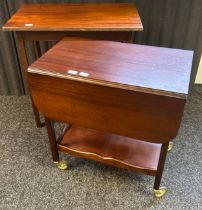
[{"left": 28, "top": 38, "right": 193, "bottom": 143}]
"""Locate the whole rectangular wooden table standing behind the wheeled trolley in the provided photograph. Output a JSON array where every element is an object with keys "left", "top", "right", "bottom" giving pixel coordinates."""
[{"left": 3, "top": 3, "right": 143, "bottom": 127}]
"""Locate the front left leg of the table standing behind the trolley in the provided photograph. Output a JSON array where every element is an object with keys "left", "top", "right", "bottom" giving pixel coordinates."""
[{"left": 16, "top": 32, "right": 44, "bottom": 128}]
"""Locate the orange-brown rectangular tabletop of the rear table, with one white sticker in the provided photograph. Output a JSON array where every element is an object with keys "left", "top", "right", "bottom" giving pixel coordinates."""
[{"left": 4, "top": 3, "right": 143, "bottom": 31}]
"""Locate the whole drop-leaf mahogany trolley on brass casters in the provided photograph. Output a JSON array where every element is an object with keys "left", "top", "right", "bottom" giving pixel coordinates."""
[{"left": 27, "top": 38, "right": 193, "bottom": 197}]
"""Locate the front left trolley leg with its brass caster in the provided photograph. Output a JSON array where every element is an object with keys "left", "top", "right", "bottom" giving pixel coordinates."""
[{"left": 45, "top": 117, "right": 68, "bottom": 170}]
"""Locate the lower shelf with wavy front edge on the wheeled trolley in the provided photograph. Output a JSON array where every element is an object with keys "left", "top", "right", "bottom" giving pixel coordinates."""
[{"left": 58, "top": 126, "right": 161, "bottom": 175}]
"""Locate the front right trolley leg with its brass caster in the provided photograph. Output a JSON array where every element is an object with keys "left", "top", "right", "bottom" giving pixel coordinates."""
[{"left": 154, "top": 143, "right": 169, "bottom": 198}]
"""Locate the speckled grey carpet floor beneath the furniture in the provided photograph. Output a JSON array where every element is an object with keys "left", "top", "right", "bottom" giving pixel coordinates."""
[{"left": 0, "top": 86, "right": 202, "bottom": 210}]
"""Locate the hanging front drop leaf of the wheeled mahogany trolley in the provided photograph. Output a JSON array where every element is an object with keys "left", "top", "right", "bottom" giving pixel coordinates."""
[{"left": 28, "top": 73, "right": 185, "bottom": 143}]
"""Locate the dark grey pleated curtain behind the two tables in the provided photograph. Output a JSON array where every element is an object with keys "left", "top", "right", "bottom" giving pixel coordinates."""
[{"left": 0, "top": 0, "right": 202, "bottom": 95}]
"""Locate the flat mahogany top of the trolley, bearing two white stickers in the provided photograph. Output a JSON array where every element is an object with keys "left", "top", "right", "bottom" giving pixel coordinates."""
[{"left": 28, "top": 38, "right": 193, "bottom": 98}]
